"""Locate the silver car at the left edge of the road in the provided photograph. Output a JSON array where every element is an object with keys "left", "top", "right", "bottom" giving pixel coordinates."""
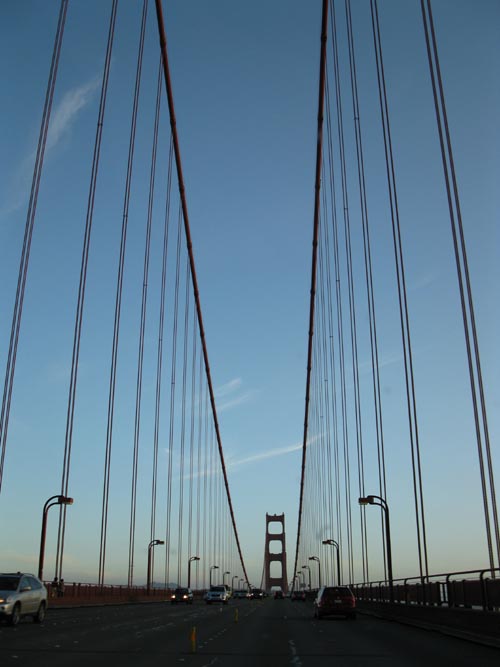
[{"left": 0, "top": 572, "right": 47, "bottom": 625}]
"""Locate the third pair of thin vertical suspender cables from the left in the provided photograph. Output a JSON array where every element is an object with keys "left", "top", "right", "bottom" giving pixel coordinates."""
[{"left": 99, "top": 0, "right": 148, "bottom": 586}]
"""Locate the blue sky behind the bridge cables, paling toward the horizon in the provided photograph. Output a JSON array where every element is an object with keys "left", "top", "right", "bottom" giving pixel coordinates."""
[{"left": 0, "top": 0, "right": 500, "bottom": 583}]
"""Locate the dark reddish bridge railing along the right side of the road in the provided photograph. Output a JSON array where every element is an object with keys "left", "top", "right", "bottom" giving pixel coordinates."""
[{"left": 352, "top": 568, "right": 500, "bottom": 611}]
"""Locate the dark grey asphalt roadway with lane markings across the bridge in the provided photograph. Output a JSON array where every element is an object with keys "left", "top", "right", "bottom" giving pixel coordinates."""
[{"left": 0, "top": 598, "right": 500, "bottom": 667}]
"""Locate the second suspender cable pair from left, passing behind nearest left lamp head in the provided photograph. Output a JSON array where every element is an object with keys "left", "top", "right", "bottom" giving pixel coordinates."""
[{"left": 55, "top": 0, "right": 118, "bottom": 579}]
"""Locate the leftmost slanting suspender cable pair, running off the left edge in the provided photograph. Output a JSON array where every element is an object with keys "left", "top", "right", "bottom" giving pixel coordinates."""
[{"left": 0, "top": 0, "right": 68, "bottom": 491}]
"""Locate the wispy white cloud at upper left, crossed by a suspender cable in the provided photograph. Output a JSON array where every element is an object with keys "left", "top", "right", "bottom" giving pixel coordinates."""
[{"left": 0, "top": 77, "right": 100, "bottom": 218}]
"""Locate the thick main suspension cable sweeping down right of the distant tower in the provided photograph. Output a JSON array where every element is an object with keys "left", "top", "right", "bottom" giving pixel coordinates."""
[{"left": 293, "top": 0, "right": 328, "bottom": 584}]
